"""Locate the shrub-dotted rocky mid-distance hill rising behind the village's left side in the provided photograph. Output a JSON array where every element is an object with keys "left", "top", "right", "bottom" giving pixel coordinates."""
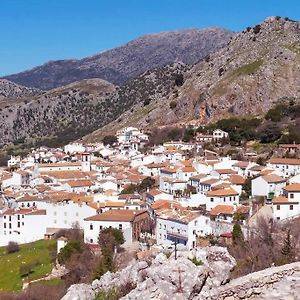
[{"left": 0, "top": 63, "right": 189, "bottom": 146}]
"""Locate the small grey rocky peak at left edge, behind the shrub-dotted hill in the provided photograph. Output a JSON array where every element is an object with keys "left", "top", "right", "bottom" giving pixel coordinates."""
[{"left": 0, "top": 79, "right": 40, "bottom": 100}]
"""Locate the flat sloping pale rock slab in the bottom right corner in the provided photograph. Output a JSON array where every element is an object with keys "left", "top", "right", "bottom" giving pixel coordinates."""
[{"left": 195, "top": 262, "right": 300, "bottom": 300}]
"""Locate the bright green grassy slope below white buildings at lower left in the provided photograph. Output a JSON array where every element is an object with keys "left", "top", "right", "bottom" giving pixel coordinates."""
[{"left": 0, "top": 240, "right": 56, "bottom": 292}]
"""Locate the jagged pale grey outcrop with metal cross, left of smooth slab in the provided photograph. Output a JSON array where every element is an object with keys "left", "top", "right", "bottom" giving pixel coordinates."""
[{"left": 63, "top": 247, "right": 235, "bottom": 300}]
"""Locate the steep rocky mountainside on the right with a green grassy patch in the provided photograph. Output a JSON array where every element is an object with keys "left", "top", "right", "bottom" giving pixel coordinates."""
[{"left": 88, "top": 17, "right": 300, "bottom": 139}]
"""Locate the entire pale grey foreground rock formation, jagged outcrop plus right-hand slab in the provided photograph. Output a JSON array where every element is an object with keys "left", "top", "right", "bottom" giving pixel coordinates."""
[{"left": 62, "top": 247, "right": 300, "bottom": 300}]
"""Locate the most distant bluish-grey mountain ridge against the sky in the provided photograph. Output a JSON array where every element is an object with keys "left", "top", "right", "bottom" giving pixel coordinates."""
[{"left": 5, "top": 28, "right": 234, "bottom": 90}]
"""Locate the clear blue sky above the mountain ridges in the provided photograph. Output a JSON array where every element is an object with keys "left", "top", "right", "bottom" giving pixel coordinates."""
[{"left": 0, "top": 0, "right": 300, "bottom": 76}]
